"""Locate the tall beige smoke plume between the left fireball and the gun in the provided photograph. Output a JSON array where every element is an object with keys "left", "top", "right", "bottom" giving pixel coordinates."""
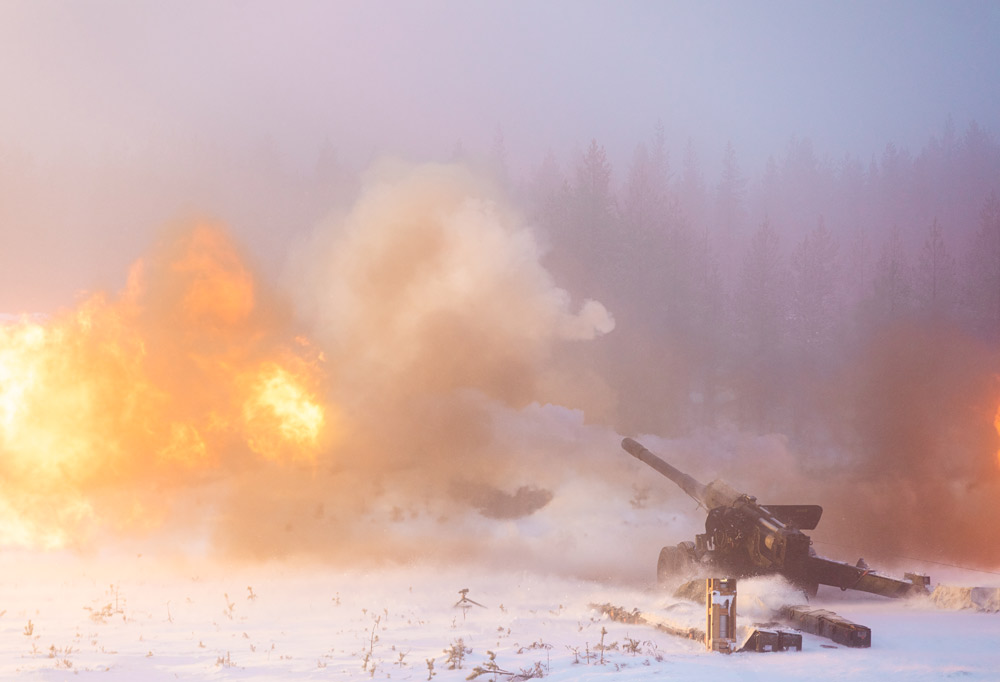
[{"left": 219, "top": 162, "right": 614, "bottom": 558}]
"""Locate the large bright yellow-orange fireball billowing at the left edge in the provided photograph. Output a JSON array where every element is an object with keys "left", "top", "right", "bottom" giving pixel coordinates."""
[{"left": 0, "top": 225, "right": 329, "bottom": 547}]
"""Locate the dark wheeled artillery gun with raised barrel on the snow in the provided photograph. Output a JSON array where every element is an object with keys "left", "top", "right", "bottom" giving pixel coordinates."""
[{"left": 622, "top": 438, "right": 929, "bottom": 597}]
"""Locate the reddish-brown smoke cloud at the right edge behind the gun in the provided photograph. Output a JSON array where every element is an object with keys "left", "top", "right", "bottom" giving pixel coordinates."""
[{"left": 821, "top": 321, "right": 1000, "bottom": 568}]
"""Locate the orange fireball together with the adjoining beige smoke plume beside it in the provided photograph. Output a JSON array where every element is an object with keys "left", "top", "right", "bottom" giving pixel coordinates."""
[{"left": 0, "top": 164, "right": 636, "bottom": 580}]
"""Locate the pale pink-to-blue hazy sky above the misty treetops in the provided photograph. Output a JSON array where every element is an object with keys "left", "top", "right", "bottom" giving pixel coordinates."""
[{"left": 0, "top": 0, "right": 1000, "bottom": 171}]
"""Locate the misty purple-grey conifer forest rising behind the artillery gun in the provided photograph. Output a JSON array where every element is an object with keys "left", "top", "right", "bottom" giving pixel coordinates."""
[{"left": 504, "top": 121, "right": 1000, "bottom": 441}]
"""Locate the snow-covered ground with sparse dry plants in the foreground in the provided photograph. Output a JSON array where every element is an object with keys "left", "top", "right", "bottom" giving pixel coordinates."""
[{"left": 0, "top": 551, "right": 1000, "bottom": 682}]
